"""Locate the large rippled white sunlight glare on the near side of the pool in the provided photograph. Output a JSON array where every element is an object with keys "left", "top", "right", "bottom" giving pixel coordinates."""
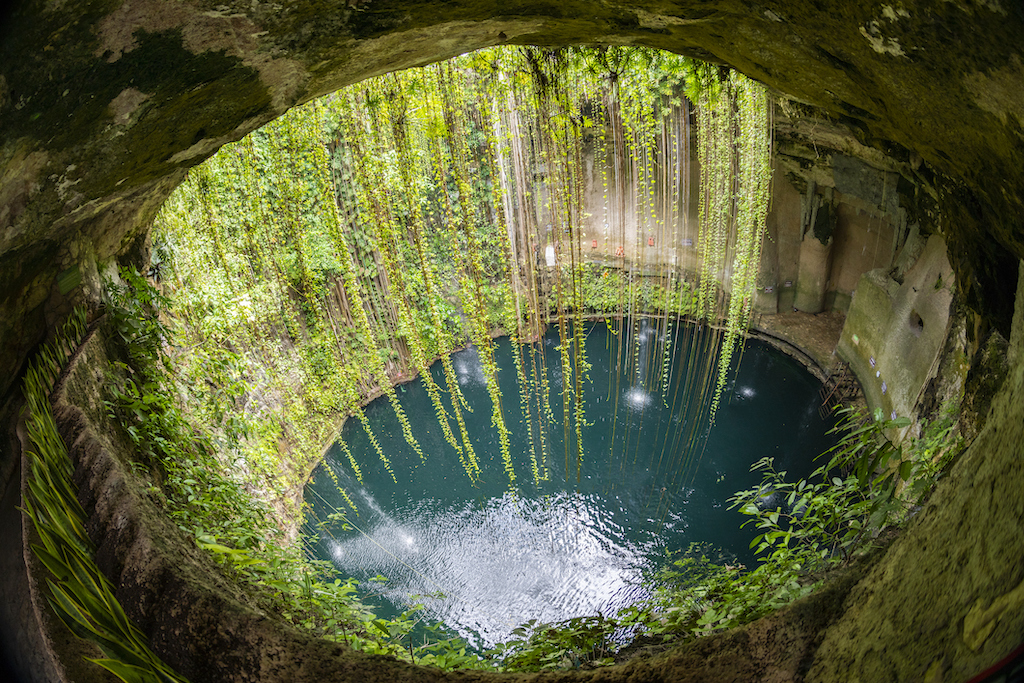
[{"left": 330, "top": 492, "right": 647, "bottom": 646}]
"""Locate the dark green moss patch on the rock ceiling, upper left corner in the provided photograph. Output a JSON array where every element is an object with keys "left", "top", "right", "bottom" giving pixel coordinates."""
[{"left": 5, "top": 16, "right": 270, "bottom": 196}]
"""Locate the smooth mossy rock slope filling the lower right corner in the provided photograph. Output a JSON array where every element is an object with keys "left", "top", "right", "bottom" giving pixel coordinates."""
[{"left": 807, "top": 263, "right": 1024, "bottom": 683}]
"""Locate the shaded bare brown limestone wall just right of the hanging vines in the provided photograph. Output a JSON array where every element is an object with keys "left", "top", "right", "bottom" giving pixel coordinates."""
[{"left": 759, "top": 118, "right": 921, "bottom": 313}]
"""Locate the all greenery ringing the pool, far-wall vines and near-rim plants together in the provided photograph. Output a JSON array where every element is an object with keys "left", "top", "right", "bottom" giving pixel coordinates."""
[{"left": 18, "top": 46, "right": 966, "bottom": 670}]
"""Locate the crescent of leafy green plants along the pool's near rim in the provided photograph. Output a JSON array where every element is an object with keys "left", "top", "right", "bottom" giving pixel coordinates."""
[{"left": 86, "top": 272, "right": 956, "bottom": 671}]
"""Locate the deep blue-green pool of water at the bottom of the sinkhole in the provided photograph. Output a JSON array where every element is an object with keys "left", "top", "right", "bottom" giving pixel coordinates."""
[{"left": 305, "top": 319, "right": 831, "bottom": 645}]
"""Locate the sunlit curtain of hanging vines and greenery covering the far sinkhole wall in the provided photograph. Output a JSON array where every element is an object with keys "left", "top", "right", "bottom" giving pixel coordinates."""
[{"left": 156, "top": 48, "right": 770, "bottom": 520}]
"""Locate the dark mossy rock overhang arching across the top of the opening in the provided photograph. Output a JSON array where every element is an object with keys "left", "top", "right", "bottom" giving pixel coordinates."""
[{"left": 0, "top": 5, "right": 1024, "bottom": 393}]
